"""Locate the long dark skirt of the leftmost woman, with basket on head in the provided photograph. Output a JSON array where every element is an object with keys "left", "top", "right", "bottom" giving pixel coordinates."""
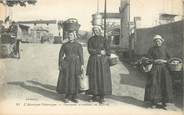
[{"left": 56, "top": 58, "right": 81, "bottom": 94}]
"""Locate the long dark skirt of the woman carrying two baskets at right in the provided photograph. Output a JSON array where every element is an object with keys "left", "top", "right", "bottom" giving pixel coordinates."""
[{"left": 144, "top": 64, "right": 173, "bottom": 104}]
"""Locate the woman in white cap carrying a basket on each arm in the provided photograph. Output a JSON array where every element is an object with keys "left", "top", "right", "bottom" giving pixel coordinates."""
[{"left": 145, "top": 35, "right": 173, "bottom": 109}]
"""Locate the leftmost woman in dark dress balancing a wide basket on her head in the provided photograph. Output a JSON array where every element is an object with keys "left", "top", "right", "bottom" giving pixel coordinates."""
[{"left": 57, "top": 33, "right": 84, "bottom": 103}]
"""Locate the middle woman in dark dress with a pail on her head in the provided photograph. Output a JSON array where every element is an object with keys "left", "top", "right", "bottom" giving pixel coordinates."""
[{"left": 86, "top": 26, "right": 112, "bottom": 103}]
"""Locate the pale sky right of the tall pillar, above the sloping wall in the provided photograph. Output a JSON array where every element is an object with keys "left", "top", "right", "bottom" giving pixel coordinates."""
[{"left": 130, "top": 0, "right": 183, "bottom": 27}]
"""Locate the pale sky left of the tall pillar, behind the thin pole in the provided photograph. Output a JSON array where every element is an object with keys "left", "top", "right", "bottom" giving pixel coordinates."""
[{"left": 0, "top": 0, "right": 120, "bottom": 30}]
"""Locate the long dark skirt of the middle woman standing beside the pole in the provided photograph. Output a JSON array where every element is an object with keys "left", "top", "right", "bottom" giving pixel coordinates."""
[{"left": 87, "top": 55, "right": 112, "bottom": 95}]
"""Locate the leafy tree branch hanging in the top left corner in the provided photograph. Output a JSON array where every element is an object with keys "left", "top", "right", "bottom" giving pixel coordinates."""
[{"left": 0, "top": 0, "right": 37, "bottom": 7}]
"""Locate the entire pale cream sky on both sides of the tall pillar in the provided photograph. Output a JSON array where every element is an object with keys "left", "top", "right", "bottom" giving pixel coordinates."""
[{"left": 0, "top": 0, "right": 182, "bottom": 30}]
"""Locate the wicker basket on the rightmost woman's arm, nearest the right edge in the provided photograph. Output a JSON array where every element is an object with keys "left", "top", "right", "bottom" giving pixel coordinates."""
[{"left": 168, "top": 58, "right": 183, "bottom": 71}]
